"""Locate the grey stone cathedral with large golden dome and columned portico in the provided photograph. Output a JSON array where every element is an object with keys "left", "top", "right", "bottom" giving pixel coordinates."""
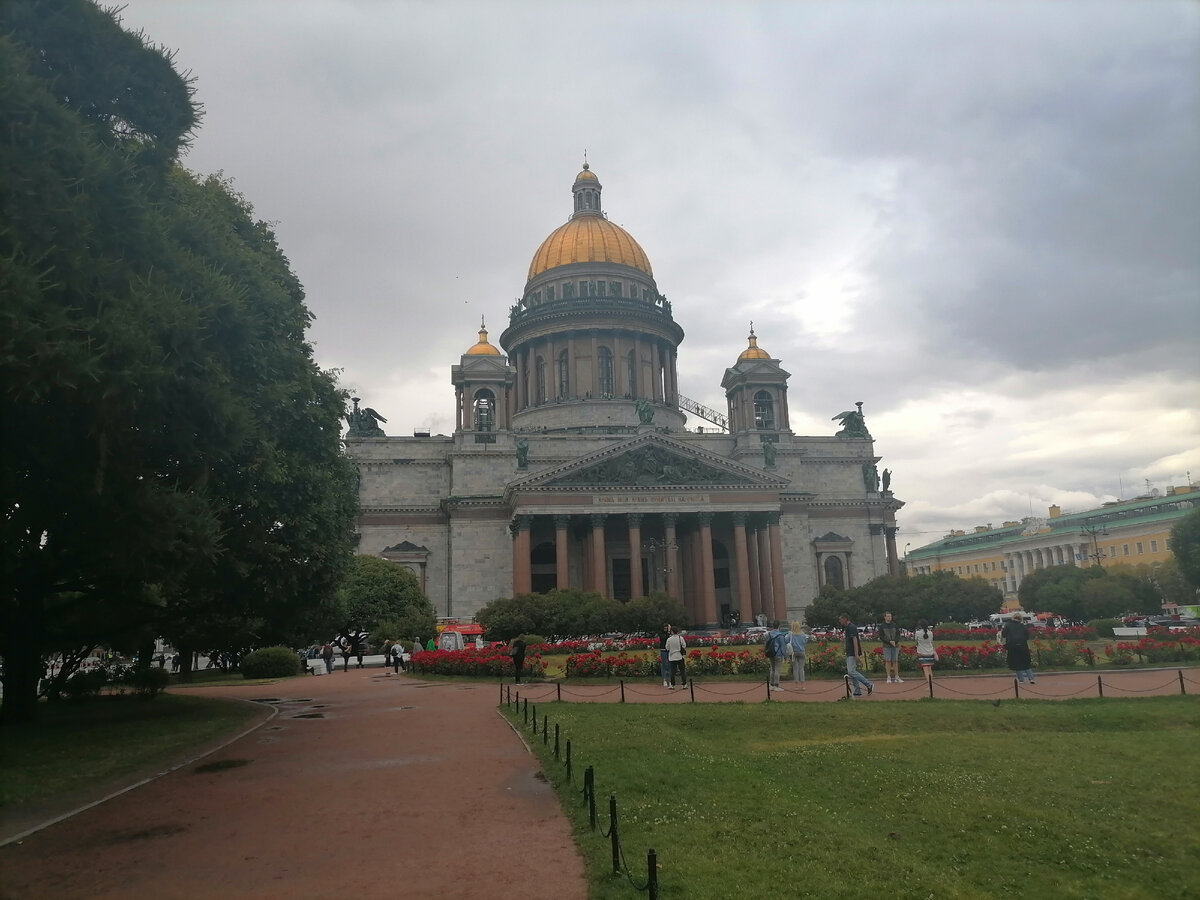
[{"left": 347, "top": 163, "right": 902, "bottom": 625}]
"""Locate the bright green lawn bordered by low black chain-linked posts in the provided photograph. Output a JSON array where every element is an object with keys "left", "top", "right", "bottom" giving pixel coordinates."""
[{"left": 516, "top": 696, "right": 1200, "bottom": 900}]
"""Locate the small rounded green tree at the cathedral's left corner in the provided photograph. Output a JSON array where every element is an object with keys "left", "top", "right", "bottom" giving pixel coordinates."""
[{"left": 336, "top": 556, "right": 437, "bottom": 640}]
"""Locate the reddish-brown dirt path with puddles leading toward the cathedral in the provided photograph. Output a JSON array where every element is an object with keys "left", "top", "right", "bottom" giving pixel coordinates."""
[{"left": 0, "top": 668, "right": 587, "bottom": 900}]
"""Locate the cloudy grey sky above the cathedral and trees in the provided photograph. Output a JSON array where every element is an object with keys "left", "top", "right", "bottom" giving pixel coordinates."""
[{"left": 114, "top": 0, "right": 1200, "bottom": 547}]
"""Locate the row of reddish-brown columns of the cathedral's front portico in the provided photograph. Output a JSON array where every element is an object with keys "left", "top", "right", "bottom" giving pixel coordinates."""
[{"left": 510, "top": 510, "right": 787, "bottom": 625}]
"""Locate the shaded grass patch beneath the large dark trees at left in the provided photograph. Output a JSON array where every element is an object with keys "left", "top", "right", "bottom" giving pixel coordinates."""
[{"left": 0, "top": 694, "right": 258, "bottom": 809}]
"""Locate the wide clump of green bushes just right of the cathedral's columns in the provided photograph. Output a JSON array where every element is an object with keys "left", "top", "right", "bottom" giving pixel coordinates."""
[{"left": 805, "top": 571, "right": 1003, "bottom": 628}]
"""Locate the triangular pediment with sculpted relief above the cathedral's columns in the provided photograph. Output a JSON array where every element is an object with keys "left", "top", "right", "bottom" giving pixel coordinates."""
[{"left": 509, "top": 434, "right": 788, "bottom": 491}]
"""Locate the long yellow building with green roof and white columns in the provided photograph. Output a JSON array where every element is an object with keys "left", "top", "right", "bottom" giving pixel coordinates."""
[{"left": 905, "top": 485, "right": 1200, "bottom": 606}]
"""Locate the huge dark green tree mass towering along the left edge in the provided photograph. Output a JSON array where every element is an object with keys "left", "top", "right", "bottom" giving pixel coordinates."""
[{"left": 0, "top": 0, "right": 355, "bottom": 720}]
